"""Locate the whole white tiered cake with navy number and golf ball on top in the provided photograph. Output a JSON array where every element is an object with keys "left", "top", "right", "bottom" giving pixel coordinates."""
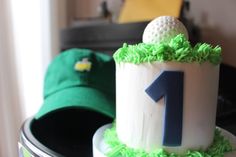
[{"left": 93, "top": 16, "right": 236, "bottom": 157}]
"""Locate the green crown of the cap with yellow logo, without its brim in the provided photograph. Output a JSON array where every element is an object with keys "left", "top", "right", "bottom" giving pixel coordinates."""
[{"left": 44, "top": 48, "right": 115, "bottom": 98}]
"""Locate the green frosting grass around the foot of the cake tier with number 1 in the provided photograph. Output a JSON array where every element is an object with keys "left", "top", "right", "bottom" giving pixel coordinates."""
[{"left": 104, "top": 124, "right": 234, "bottom": 157}]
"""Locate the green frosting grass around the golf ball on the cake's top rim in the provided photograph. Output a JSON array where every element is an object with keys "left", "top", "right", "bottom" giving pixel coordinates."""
[{"left": 113, "top": 34, "right": 221, "bottom": 65}]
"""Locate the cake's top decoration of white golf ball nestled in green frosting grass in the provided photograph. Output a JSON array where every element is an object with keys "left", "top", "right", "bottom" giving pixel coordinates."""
[{"left": 114, "top": 16, "right": 222, "bottom": 65}]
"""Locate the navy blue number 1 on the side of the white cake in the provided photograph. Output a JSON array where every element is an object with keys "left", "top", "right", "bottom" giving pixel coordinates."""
[{"left": 145, "top": 71, "right": 184, "bottom": 147}]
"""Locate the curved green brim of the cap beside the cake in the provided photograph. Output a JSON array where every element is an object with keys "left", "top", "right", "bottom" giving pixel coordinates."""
[{"left": 35, "top": 86, "right": 115, "bottom": 119}]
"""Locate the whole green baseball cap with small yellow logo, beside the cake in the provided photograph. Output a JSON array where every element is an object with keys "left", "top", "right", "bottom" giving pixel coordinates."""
[{"left": 35, "top": 48, "right": 115, "bottom": 119}]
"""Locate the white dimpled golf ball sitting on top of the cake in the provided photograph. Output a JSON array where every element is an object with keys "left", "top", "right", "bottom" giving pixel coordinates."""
[{"left": 143, "top": 16, "right": 188, "bottom": 44}]
